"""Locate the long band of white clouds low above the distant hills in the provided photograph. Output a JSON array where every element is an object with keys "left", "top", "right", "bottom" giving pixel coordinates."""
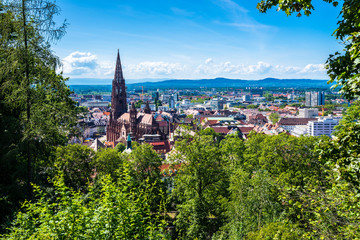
[{"left": 62, "top": 51, "right": 326, "bottom": 79}]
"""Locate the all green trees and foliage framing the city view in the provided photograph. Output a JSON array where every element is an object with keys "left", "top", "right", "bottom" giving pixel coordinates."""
[{"left": 0, "top": 0, "right": 360, "bottom": 239}]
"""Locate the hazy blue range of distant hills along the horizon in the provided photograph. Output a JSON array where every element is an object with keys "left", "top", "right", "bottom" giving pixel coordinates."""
[{"left": 68, "top": 78, "right": 331, "bottom": 91}]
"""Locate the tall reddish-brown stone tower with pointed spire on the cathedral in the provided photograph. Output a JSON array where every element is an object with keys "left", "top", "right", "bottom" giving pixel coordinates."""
[{"left": 110, "top": 50, "right": 127, "bottom": 121}]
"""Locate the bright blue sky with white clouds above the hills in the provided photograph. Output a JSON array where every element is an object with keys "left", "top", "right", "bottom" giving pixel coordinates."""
[{"left": 53, "top": 0, "right": 342, "bottom": 81}]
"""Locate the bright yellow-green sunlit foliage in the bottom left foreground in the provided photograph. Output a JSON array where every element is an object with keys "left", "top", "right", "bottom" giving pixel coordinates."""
[{"left": 3, "top": 172, "right": 168, "bottom": 239}]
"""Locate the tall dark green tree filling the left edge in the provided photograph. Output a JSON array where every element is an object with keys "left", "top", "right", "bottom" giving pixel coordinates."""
[{"left": 0, "top": 0, "right": 76, "bottom": 227}]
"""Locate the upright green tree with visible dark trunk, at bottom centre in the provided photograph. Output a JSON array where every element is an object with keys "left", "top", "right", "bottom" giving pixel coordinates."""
[{"left": 172, "top": 134, "right": 228, "bottom": 239}]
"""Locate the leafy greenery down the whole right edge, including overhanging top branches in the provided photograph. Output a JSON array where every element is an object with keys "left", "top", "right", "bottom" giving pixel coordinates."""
[{"left": 258, "top": 0, "right": 360, "bottom": 236}]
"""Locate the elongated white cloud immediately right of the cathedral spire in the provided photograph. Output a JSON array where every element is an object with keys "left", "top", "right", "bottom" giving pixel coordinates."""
[{"left": 124, "top": 61, "right": 185, "bottom": 76}]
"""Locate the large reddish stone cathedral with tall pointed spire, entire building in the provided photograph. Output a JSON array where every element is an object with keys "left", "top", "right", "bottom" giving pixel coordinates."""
[{"left": 106, "top": 51, "right": 166, "bottom": 145}]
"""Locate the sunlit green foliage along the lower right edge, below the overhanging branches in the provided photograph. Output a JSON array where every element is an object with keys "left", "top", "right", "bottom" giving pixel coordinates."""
[{"left": 292, "top": 101, "right": 360, "bottom": 239}]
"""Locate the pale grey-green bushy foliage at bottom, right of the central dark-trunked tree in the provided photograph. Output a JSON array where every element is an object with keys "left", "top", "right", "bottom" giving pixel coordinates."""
[{"left": 226, "top": 168, "right": 281, "bottom": 239}]
